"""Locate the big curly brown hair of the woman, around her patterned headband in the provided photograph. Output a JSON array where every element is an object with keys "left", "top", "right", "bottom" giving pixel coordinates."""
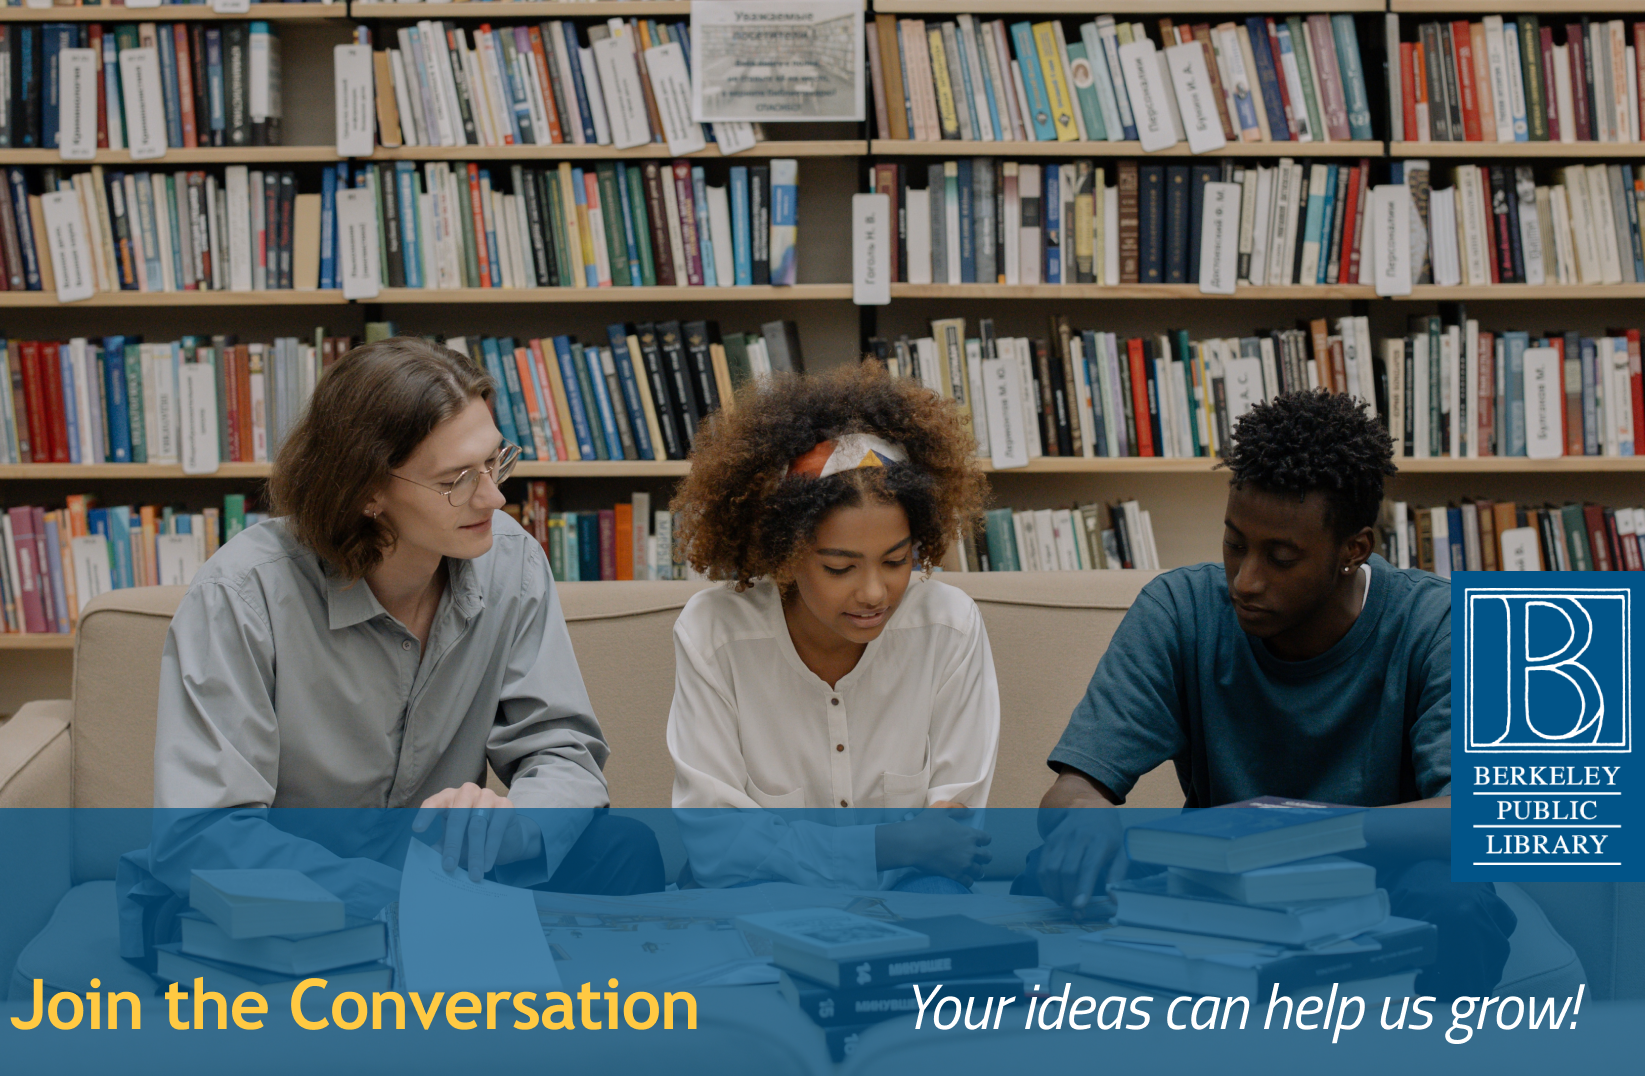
[{"left": 671, "top": 362, "right": 987, "bottom": 589}]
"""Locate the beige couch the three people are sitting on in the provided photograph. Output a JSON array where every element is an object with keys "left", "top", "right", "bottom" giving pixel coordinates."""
[{"left": 0, "top": 573, "right": 1618, "bottom": 995}]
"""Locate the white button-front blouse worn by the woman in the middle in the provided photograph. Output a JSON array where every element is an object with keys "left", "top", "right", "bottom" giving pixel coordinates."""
[{"left": 668, "top": 577, "right": 1000, "bottom": 888}]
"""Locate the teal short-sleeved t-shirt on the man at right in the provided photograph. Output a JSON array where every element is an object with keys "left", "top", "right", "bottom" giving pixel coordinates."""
[{"left": 1051, "top": 556, "right": 1451, "bottom": 806}]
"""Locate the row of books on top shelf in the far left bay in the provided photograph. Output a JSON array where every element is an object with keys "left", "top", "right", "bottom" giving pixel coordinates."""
[{"left": 0, "top": 21, "right": 281, "bottom": 150}]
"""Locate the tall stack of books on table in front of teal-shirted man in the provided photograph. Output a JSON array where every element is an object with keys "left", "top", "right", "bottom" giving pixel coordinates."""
[{"left": 1053, "top": 796, "right": 1438, "bottom": 1000}]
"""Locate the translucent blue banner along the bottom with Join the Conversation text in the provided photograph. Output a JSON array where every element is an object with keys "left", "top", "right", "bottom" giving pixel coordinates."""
[{"left": 0, "top": 812, "right": 1645, "bottom": 1074}]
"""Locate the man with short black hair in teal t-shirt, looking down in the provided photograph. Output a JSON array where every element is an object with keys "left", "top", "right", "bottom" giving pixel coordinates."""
[{"left": 1017, "top": 392, "right": 1515, "bottom": 995}]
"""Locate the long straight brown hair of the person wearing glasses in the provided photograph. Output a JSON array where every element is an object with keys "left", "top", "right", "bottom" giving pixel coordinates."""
[{"left": 268, "top": 336, "right": 497, "bottom": 579}]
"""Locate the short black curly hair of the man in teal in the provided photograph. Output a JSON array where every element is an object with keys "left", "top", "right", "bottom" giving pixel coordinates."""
[{"left": 1219, "top": 390, "right": 1397, "bottom": 540}]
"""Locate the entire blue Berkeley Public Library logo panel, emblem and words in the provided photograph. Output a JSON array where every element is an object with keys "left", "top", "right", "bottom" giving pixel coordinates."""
[{"left": 1451, "top": 571, "right": 1645, "bottom": 882}]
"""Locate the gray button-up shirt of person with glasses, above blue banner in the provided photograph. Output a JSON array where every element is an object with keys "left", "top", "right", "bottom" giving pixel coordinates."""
[{"left": 155, "top": 512, "right": 609, "bottom": 808}]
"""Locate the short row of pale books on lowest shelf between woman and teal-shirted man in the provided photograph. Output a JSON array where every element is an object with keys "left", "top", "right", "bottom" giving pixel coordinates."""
[{"left": 959, "top": 500, "right": 1160, "bottom": 571}]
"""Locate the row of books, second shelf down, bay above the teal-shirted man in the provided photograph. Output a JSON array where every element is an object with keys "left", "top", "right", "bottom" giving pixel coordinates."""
[{"left": 872, "top": 158, "right": 1372, "bottom": 286}]
